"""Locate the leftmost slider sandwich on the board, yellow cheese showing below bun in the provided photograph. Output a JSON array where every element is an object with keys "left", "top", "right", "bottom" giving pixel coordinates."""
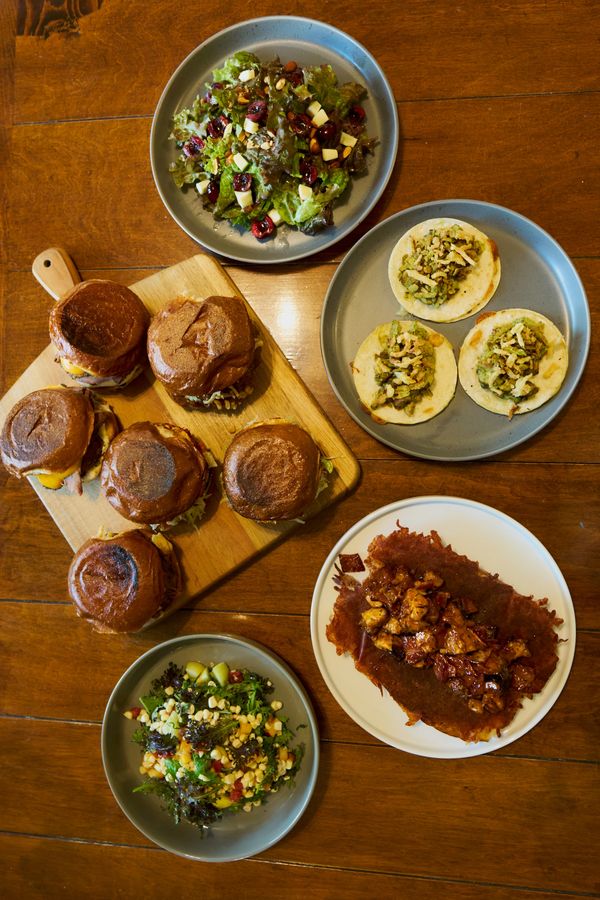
[{"left": 0, "top": 386, "right": 119, "bottom": 493}]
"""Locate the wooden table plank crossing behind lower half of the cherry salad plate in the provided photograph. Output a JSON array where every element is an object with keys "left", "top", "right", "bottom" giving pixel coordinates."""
[{"left": 9, "top": 94, "right": 598, "bottom": 269}]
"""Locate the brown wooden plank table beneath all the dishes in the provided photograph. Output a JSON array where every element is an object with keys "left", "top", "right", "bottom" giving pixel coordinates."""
[{"left": 0, "top": 0, "right": 600, "bottom": 900}]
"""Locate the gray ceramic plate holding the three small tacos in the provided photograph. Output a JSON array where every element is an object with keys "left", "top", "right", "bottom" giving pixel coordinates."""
[{"left": 321, "top": 200, "right": 590, "bottom": 461}]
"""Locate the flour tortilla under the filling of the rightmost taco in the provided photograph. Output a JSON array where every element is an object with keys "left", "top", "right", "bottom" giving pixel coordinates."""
[{"left": 458, "top": 309, "right": 569, "bottom": 418}]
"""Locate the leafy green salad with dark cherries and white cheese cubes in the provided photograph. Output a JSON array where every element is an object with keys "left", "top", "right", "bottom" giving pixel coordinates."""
[{"left": 170, "top": 51, "right": 375, "bottom": 240}]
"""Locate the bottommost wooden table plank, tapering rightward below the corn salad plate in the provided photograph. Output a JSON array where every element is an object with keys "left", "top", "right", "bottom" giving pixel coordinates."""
[{"left": 0, "top": 834, "right": 581, "bottom": 900}]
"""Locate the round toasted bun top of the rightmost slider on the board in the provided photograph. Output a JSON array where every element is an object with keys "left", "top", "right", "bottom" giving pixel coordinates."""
[{"left": 223, "top": 422, "right": 321, "bottom": 522}]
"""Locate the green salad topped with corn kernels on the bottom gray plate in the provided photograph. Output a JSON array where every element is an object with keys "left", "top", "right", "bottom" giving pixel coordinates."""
[{"left": 124, "top": 661, "right": 303, "bottom": 828}]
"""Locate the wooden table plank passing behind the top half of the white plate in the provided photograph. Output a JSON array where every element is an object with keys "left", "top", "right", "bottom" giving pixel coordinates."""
[{"left": 0, "top": 460, "right": 600, "bottom": 628}]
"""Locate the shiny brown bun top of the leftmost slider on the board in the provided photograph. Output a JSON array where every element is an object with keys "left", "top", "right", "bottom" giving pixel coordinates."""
[{"left": 0, "top": 387, "right": 94, "bottom": 475}]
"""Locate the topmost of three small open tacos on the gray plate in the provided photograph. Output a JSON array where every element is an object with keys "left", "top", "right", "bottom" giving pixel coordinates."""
[{"left": 388, "top": 218, "right": 500, "bottom": 322}]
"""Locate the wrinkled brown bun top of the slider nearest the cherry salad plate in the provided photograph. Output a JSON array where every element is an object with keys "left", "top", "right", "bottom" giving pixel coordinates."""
[{"left": 148, "top": 297, "right": 254, "bottom": 402}]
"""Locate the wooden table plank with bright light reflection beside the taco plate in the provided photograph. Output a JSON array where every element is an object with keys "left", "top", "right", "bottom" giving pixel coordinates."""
[{"left": 0, "top": 258, "right": 600, "bottom": 463}]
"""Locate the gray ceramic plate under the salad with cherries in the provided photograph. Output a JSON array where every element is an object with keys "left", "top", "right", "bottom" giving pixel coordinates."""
[{"left": 150, "top": 16, "right": 398, "bottom": 263}]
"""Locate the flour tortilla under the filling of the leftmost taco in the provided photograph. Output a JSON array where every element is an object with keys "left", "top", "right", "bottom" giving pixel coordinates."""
[{"left": 352, "top": 320, "right": 458, "bottom": 425}]
